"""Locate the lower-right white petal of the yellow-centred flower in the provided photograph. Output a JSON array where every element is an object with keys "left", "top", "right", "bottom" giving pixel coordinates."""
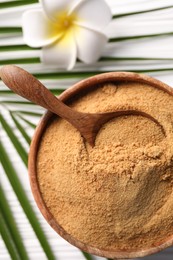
[{"left": 75, "top": 26, "right": 107, "bottom": 64}]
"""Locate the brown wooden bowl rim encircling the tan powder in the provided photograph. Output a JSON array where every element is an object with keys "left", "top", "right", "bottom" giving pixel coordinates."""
[{"left": 29, "top": 72, "right": 173, "bottom": 259}]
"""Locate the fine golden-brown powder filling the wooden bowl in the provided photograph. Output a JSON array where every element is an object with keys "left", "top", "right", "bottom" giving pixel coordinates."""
[{"left": 37, "top": 83, "right": 173, "bottom": 250}]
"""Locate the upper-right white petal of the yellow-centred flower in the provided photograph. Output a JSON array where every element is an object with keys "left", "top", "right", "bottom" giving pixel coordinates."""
[{"left": 74, "top": 0, "right": 112, "bottom": 31}]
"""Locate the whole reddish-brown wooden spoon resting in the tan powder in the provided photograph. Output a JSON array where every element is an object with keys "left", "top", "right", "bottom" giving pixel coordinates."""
[{"left": 0, "top": 65, "right": 158, "bottom": 147}]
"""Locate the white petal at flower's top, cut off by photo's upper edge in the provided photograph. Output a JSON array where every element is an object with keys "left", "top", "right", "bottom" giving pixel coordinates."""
[{"left": 41, "top": 0, "right": 81, "bottom": 22}]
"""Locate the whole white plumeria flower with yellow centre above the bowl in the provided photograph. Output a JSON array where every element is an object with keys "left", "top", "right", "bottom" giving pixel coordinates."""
[{"left": 22, "top": 0, "right": 111, "bottom": 69}]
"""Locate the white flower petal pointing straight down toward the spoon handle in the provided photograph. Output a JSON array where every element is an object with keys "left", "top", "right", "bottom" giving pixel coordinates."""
[{"left": 41, "top": 31, "right": 77, "bottom": 70}]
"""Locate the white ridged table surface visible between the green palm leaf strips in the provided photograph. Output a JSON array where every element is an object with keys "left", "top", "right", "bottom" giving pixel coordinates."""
[{"left": 0, "top": 0, "right": 173, "bottom": 260}]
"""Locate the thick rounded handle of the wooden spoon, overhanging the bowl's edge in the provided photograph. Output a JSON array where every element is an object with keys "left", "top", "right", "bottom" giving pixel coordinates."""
[{"left": 0, "top": 65, "right": 77, "bottom": 121}]
